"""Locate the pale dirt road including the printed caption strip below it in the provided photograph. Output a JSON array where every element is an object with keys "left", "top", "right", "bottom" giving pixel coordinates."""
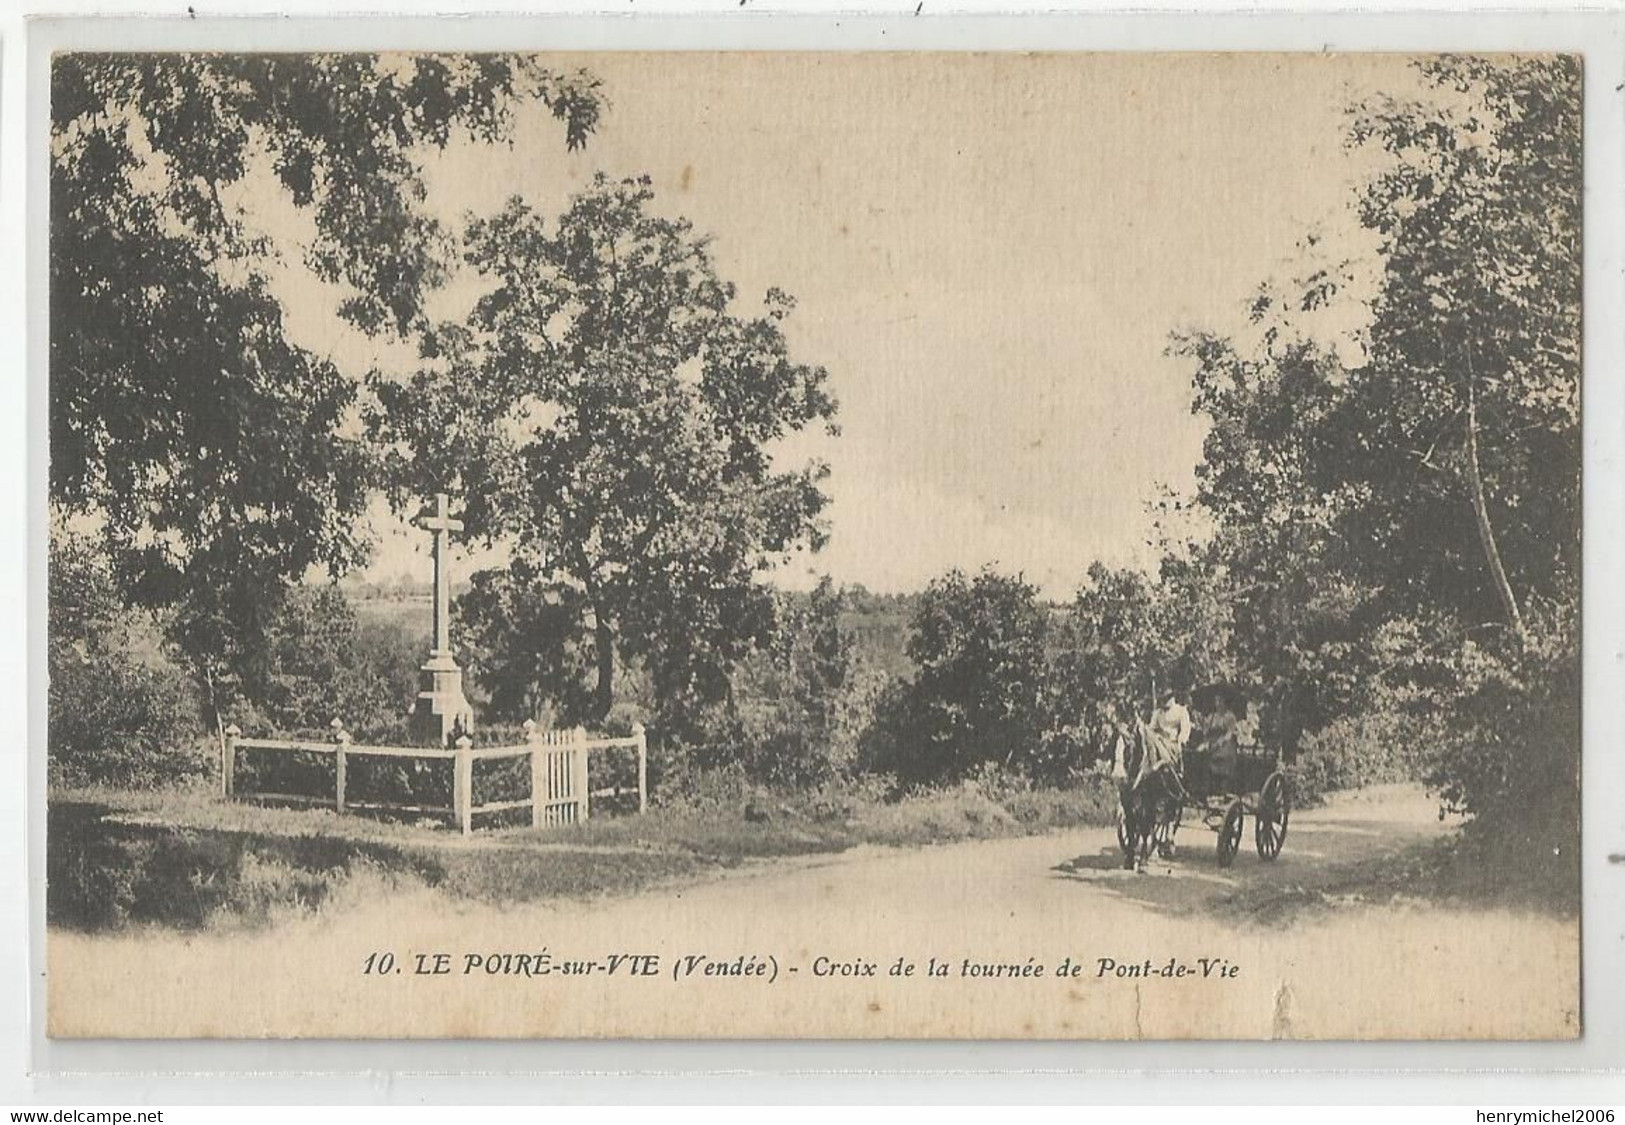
[{"left": 49, "top": 788, "right": 1580, "bottom": 1039}]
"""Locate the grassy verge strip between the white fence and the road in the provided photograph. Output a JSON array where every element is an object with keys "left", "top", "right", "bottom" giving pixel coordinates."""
[{"left": 47, "top": 777, "right": 1116, "bottom": 932}]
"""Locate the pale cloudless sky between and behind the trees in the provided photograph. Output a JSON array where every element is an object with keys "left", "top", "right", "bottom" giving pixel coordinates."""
[{"left": 267, "top": 52, "right": 1409, "bottom": 597}]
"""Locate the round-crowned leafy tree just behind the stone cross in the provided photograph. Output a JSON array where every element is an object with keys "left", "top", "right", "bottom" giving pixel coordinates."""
[{"left": 372, "top": 176, "right": 835, "bottom": 719}]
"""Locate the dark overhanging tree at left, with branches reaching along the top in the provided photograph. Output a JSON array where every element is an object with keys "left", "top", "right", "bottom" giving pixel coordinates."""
[{"left": 50, "top": 54, "right": 598, "bottom": 715}]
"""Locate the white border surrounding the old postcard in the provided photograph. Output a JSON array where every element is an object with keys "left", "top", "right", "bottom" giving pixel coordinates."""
[{"left": 0, "top": 0, "right": 1625, "bottom": 1120}]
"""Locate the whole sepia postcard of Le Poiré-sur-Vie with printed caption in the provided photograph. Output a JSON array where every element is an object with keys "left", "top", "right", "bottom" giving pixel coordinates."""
[{"left": 41, "top": 52, "right": 1581, "bottom": 1040}]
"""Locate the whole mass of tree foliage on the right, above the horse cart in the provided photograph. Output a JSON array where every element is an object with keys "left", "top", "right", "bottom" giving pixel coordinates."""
[{"left": 1172, "top": 57, "right": 1581, "bottom": 811}]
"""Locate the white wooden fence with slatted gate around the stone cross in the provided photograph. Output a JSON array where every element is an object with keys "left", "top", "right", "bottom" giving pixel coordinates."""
[{"left": 219, "top": 719, "right": 648, "bottom": 836}]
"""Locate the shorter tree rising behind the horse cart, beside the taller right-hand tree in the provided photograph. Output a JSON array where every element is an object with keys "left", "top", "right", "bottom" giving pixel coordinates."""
[{"left": 1172, "top": 326, "right": 1380, "bottom": 754}]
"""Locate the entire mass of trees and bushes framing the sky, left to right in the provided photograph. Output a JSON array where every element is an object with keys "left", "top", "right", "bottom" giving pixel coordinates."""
[{"left": 50, "top": 55, "right": 1581, "bottom": 823}]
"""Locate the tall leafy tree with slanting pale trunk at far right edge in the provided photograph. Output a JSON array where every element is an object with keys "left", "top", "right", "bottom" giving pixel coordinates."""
[{"left": 1336, "top": 55, "right": 1583, "bottom": 632}]
